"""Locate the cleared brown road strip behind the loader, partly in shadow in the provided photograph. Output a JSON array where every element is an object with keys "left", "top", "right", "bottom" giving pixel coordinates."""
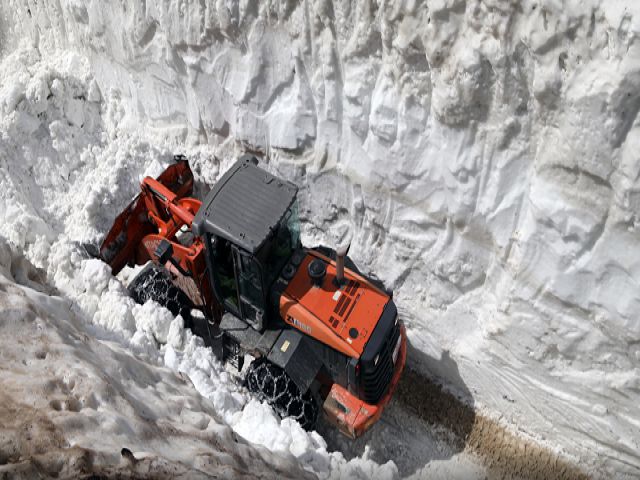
[{"left": 319, "top": 368, "right": 589, "bottom": 480}]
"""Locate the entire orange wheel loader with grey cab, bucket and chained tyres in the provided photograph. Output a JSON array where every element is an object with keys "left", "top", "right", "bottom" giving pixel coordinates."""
[{"left": 100, "top": 157, "right": 406, "bottom": 438}]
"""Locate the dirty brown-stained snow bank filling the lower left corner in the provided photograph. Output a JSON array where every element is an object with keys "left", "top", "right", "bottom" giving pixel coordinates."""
[{"left": 0, "top": 237, "right": 313, "bottom": 479}]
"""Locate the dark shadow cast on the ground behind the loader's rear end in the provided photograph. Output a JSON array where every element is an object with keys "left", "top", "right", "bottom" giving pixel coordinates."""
[{"left": 317, "top": 342, "right": 476, "bottom": 477}]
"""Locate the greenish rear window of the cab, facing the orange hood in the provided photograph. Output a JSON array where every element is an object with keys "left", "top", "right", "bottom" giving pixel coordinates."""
[{"left": 258, "top": 201, "right": 300, "bottom": 285}]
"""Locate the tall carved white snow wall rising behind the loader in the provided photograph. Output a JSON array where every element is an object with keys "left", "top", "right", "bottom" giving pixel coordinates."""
[{"left": 0, "top": 0, "right": 640, "bottom": 475}]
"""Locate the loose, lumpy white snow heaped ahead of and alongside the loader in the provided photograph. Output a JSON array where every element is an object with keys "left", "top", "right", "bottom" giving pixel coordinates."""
[{"left": 0, "top": 48, "right": 397, "bottom": 478}]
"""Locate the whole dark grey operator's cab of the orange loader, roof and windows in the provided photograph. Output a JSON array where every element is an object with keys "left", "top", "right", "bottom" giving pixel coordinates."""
[{"left": 192, "top": 157, "right": 301, "bottom": 331}]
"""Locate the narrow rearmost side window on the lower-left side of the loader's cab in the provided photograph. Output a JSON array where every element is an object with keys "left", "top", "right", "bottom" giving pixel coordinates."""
[{"left": 234, "top": 248, "right": 266, "bottom": 331}]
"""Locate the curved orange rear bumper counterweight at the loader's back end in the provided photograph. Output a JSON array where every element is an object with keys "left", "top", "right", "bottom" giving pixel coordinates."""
[{"left": 323, "top": 324, "right": 407, "bottom": 438}]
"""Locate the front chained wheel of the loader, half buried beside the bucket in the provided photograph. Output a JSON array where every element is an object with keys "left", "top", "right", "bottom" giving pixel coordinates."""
[{"left": 128, "top": 264, "right": 193, "bottom": 326}]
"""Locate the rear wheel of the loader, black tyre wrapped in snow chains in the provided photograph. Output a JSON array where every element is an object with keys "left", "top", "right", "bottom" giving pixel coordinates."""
[{"left": 245, "top": 358, "right": 318, "bottom": 430}]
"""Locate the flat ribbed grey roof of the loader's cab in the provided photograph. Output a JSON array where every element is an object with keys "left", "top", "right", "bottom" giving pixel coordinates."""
[{"left": 192, "top": 156, "right": 298, "bottom": 254}]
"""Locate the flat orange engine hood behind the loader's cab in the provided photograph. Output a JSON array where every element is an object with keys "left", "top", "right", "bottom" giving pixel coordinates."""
[{"left": 280, "top": 251, "right": 389, "bottom": 358}]
